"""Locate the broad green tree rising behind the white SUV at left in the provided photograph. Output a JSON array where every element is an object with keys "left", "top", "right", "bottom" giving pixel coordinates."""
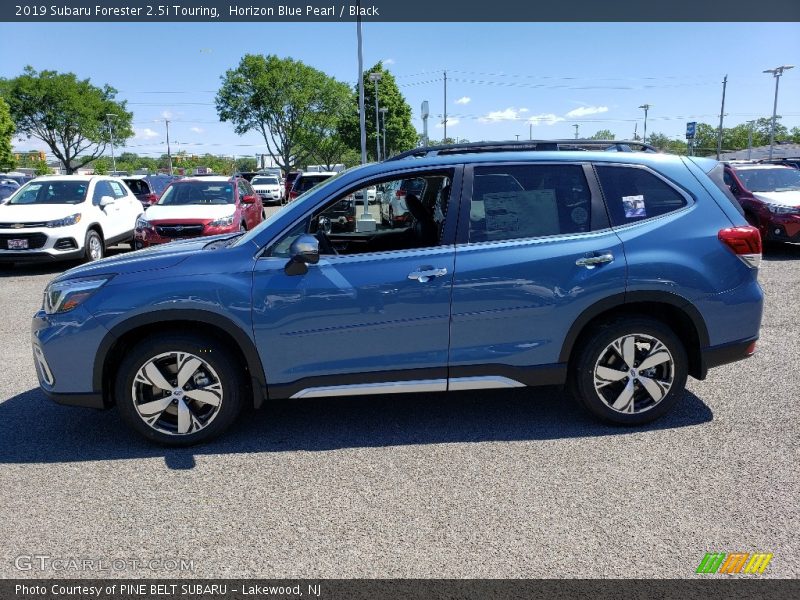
[{"left": 0, "top": 66, "right": 133, "bottom": 173}]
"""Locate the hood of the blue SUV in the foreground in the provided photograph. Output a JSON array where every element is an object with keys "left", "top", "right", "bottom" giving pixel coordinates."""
[{"left": 53, "top": 235, "right": 219, "bottom": 281}]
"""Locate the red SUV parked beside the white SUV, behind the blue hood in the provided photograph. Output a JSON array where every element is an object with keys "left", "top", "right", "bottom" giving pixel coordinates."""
[{"left": 134, "top": 177, "right": 264, "bottom": 249}]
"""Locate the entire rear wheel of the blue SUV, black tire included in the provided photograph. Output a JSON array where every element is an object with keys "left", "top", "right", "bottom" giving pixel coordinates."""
[{"left": 570, "top": 317, "right": 689, "bottom": 425}]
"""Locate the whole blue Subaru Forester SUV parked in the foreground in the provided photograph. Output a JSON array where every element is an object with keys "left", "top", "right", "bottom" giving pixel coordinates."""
[{"left": 32, "top": 141, "right": 763, "bottom": 445}]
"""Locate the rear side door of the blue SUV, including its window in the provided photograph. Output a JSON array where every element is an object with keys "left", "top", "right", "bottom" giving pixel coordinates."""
[{"left": 449, "top": 163, "right": 627, "bottom": 384}]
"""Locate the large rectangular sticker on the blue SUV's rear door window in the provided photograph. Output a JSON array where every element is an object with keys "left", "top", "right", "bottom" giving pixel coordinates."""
[{"left": 483, "top": 190, "right": 559, "bottom": 239}]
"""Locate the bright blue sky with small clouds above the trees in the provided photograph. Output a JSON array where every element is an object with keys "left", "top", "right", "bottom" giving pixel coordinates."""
[{"left": 0, "top": 23, "right": 800, "bottom": 155}]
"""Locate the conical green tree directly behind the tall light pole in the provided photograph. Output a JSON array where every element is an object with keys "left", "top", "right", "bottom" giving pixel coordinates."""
[{"left": 340, "top": 62, "right": 419, "bottom": 160}]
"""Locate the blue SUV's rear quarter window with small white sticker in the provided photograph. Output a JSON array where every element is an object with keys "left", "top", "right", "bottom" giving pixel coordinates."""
[{"left": 595, "top": 165, "right": 688, "bottom": 226}]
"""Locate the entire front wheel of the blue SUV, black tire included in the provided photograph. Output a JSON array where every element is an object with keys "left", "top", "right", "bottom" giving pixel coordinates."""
[{"left": 114, "top": 334, "right": 244, "bottom": 446}]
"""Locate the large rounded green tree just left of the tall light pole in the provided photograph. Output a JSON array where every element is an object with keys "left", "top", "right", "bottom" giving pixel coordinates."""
[{"left": 216, "top": 54, "right": 349, "bottom": 172}]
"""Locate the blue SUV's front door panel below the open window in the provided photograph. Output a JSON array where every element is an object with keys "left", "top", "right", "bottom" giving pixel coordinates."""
[{"left": 253, "top": 246, "right": 455, "bottom": 397}]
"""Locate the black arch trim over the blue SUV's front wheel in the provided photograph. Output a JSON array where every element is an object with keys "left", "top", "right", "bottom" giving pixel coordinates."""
[{"left": 92, "top": 309, "right": 267, "bottom": 408}]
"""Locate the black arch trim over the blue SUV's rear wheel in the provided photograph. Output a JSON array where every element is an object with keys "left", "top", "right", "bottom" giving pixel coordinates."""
[{"left": 558, "top": 290, "right": 709, "bottom": 363}]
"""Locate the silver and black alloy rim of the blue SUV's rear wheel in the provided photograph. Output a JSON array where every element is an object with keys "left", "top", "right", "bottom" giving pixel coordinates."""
[{"left": 594, "top": 333, "right": 675, "bottom": 414}]
